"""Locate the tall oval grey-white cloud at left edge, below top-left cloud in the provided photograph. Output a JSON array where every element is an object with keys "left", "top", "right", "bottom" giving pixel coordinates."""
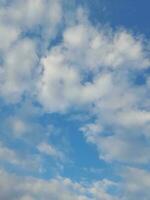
[{"left": 0, "top": 39, "right": 37, "bottom": 102}]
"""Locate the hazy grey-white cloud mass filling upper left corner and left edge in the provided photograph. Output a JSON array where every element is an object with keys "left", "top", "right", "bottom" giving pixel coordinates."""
[{"left": 0, "top": 0, "right": 62, "bottom": 102}]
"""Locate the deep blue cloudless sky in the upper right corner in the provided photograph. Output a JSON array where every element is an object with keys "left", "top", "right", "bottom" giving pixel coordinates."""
[{"left": 76, "top": 0, "right": 150, "bottom": 38}]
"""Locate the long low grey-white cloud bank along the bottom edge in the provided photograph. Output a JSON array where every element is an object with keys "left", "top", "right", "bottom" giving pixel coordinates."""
[{"left": 0, "top": 170, "right": 117, "bottom": 200}]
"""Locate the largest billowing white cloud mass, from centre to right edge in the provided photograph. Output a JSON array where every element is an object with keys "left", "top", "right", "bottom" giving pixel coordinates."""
[{"left": 37, "top": 15, "right": 150, "bottom": 167}]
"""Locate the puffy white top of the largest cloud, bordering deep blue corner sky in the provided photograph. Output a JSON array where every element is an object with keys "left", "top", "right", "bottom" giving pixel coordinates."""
[{"left": 64, "top": 22, "right": 150, "bottom": 69}]
